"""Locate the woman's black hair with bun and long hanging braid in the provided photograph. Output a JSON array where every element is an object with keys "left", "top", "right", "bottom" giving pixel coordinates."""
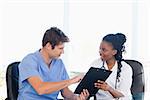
[{"left": 102, "top": 33, "right": 126, "bottom": 81}]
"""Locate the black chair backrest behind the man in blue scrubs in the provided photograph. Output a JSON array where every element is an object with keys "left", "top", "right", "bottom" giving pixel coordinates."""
[{"left": 6, "top": 62, "right": 20, "bottom": 100}]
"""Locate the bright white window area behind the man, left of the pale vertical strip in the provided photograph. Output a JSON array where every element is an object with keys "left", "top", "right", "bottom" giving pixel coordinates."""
[{"left": 0, "top": 0, "right": 64, "bottom": 68}]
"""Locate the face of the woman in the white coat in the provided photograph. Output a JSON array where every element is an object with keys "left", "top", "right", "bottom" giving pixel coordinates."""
[{"left": 99, "top": 41, "right": 117, "bottom": 61}]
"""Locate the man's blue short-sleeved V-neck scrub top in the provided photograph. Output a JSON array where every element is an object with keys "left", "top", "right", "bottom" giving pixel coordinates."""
[{"left": 18, "top": 51, "right": 69, "bottom": 100}]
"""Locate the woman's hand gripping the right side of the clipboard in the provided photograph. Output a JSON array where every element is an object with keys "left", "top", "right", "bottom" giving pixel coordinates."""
[{"left": 95, "top": 80, "right": 111, "bottom": 91}]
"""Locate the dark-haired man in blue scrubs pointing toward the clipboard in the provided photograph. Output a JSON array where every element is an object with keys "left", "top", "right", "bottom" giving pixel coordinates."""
[{"left": 18, "top": 27, "right": 89, "bottom": 100}]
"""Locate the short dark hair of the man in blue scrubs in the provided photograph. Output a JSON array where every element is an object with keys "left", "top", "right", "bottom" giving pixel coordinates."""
[{"left": 42, "top": 27, "right": 69, "bottom": 49}]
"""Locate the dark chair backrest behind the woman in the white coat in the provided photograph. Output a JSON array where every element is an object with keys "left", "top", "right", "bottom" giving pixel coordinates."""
[{"left": 124, "top": 60, "right": 145, "bottom": 100}]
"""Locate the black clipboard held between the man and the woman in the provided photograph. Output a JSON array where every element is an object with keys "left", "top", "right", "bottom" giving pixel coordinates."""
[{"left": 74, "top": 67, "right": 112, "bottom": 96}]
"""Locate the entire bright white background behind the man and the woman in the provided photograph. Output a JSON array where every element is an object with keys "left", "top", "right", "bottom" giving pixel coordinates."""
[{"left": 0, "top": 0, "right": 150, "bottom": 99}]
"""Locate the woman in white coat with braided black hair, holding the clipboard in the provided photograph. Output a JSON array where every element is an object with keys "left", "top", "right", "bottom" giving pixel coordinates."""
[{"left": 91, "top": 33, "right": 132, "bottom": 100}]
